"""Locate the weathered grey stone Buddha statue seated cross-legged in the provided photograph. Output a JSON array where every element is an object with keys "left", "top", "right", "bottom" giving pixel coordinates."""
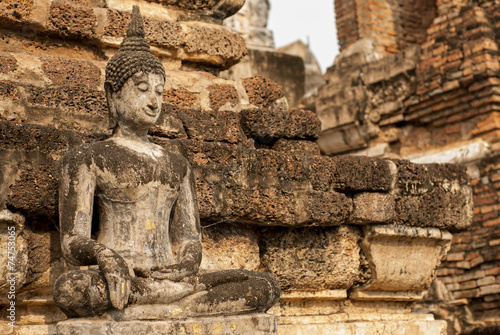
[{"left": 54, "top": 6, "right": 280, "bottom": 317}]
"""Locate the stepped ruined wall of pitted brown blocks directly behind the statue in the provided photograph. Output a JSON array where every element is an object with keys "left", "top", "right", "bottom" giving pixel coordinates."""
[{"left": 0, "top": 0, "right": 472, "bottom": 334}]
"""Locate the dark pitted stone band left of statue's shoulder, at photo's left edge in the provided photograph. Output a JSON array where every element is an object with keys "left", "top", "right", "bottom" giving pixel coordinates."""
[{"left": 0, "top": 122, "right": 81, "bottom": 217}]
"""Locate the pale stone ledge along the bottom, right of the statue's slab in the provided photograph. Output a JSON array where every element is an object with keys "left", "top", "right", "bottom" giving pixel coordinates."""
[{"left": 278, "top": 314, "right": 447, "bottom": 335}]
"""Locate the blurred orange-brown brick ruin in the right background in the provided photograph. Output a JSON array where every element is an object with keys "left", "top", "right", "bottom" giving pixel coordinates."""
[{"left": 316, "top": 1, "right": 500, "bottom": 334}]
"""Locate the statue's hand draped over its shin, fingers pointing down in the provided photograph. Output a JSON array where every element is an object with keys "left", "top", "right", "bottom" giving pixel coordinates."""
[{"left": 97, "top": 248, "right": 131, "bottom": 310}]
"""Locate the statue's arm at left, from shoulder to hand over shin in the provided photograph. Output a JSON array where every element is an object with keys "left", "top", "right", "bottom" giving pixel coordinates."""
[{"left": 59, "top": 147, "right": 131, "bottom": 309}]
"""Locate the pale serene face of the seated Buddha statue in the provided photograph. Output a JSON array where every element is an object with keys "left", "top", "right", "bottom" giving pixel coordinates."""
[{"left": 108, "top": 72, "right": 165, "bottom": 130}]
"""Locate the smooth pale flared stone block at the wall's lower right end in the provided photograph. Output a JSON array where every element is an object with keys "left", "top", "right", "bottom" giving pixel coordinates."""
[{"left": 351, "top": 225, "right": 451, "bottom": 301}]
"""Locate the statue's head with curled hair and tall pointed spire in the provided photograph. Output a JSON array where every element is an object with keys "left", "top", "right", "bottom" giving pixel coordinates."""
[{"left": 104, "top": 6, "right": 165, "bottom": 129}]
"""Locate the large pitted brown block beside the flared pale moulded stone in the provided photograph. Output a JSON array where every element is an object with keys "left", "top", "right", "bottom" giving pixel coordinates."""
[{"left": 262, "top": 226, "right": 360, "bottom": 291}]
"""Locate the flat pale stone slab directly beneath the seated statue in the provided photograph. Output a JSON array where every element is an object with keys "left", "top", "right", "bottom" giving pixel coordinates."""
[{"left": 57, "top": 314, "right": 277, "bottom": 335}]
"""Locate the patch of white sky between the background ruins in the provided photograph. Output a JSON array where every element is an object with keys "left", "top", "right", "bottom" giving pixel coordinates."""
[{"left": 267, "top": 0, "right": 338, "bottom": 72}]
